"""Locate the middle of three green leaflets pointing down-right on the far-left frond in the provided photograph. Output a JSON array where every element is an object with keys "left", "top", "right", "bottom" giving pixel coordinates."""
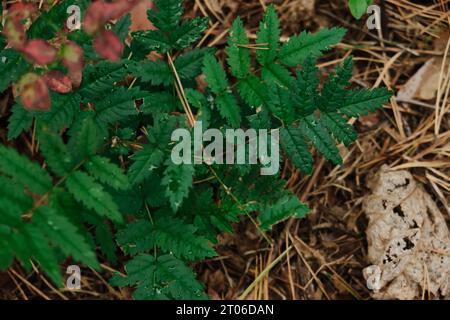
[{"left": 66, "top": 171, "right": 123, "bottom": 222}]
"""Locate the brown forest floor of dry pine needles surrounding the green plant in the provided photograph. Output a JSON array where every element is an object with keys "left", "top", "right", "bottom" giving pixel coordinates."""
[{"left": 0, "top": 0, "right": 450, "bottom": 299}]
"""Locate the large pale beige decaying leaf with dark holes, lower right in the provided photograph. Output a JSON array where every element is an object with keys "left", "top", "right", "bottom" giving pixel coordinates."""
[{"left": 363, "top": 166, "right": 450, "bottom": 299}]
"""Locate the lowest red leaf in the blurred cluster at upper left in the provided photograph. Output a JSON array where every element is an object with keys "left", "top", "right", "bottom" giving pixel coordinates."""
[{"left": 18, "top": 73, "right": 50, "bottom": 110}]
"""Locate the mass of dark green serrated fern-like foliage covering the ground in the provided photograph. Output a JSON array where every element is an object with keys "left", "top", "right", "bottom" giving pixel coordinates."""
[{"left": 0, "top": 0, "right": 391, "bottom": 299}]
